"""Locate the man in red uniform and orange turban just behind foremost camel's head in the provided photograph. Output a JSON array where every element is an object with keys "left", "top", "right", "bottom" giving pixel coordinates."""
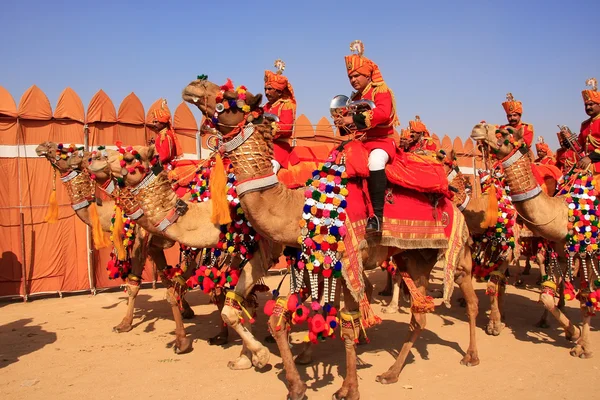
[{"left": 263, "top": 60, "right": 296, "bottom": 173}]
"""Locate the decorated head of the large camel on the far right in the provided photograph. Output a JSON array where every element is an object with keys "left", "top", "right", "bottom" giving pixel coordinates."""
[{"left": 471, "top": 122, "right": 523, "bottom": 160}]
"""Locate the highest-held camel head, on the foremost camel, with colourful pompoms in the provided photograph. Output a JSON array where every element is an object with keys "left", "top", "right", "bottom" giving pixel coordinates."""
[{"left": 181, "top": 77, "right": 262, "bottom": 134}]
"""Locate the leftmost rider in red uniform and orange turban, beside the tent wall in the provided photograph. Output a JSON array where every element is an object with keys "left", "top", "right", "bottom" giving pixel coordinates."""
[{"left": 146, "top": 99, "right": 183, "bottom": 167}]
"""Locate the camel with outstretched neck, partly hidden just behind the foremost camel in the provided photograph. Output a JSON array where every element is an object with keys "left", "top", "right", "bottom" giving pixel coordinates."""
[{"left": 89, "top": 146, "right": 282, "bottom": 370}]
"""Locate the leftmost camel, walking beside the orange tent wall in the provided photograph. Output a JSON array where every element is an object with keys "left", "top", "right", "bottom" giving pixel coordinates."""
[{"left": 36, "top": 142, "right": 202, "bottom": 354}]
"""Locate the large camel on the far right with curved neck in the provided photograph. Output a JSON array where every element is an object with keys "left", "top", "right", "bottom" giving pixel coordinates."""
[{"left": 471, "top": 122, "right": 598, "bottom": 358}]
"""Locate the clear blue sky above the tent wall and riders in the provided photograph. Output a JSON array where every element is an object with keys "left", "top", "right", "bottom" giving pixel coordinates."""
[{"left": 0, "top": 0, "right": 600, "bottom": 151}]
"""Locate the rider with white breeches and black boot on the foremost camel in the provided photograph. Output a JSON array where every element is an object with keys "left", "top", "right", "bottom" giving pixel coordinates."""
[{"left": 335, "top": 40, "right": 399, "bottom": 232}]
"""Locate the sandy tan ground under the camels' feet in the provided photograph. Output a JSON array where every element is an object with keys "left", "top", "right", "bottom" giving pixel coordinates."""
[{"left": 0, "top": 268, "right": 600, "bottom": 400}]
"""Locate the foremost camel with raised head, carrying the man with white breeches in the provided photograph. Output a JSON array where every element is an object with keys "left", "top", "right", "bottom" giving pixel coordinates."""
[{"left": 182, "top": 79, "right": 479, "bottom": 400}]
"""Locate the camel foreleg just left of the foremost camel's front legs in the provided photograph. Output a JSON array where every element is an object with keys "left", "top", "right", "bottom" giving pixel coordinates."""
[{"left": 221, "top": 254, "right": 270, "bottom": 369}]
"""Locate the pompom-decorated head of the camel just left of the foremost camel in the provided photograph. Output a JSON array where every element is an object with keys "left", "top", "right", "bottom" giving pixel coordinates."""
[{"left": 106, "top": 146, "right": 157, "bottom": 186}]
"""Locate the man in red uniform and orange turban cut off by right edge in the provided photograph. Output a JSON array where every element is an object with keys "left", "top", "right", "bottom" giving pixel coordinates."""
[{"left": 577, "top": 78, "right": 600, "bottom": 174}]
